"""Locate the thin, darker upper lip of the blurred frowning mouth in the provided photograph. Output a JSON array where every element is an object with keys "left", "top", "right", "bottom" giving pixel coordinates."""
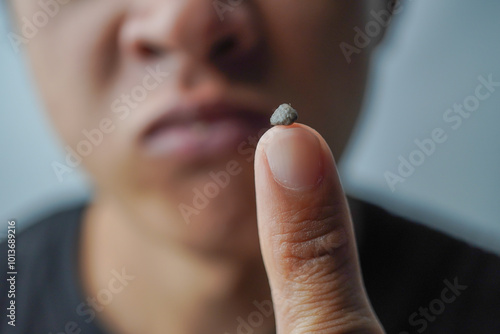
[{"left": 141, "top": 101, "right": 269, "bottom": 139}]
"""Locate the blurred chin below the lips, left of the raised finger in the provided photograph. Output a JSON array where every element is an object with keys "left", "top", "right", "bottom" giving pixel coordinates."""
[{"left": 122, "top": 147, "right": 260, "bottom": 257}]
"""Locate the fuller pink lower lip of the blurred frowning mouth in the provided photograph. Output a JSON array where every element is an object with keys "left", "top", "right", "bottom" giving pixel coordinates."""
[{"left": 141, "top": 117, "right": 269, "bottom": 161}]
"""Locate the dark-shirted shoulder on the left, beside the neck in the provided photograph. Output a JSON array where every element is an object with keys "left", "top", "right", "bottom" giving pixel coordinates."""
[{"left": 0, "top": 204, "right": 85, "bottom": 333}]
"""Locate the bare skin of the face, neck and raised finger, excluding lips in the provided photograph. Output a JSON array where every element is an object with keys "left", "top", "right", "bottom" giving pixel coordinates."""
[{"left": 11, "top": 0, "right": 386, "bottom": 334}]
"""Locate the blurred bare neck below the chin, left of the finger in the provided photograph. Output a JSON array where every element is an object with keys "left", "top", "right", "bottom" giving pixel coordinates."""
[{"left": 80, "top": 199, "right": 274, "bottom": 334}]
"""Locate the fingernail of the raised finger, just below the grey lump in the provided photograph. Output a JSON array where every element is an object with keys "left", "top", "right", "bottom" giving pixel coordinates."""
[{"left": 265, "top": 127, "right": 323, "bottom": 190}]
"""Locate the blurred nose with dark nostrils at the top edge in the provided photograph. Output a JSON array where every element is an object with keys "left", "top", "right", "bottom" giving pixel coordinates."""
[{"left": 119, "top": 0, "right": 259, "bottom": 69}]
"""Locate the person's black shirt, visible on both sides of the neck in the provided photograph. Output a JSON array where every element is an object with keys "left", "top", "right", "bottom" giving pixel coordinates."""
[{"left": 0, "top": 203, "right": 500, "bottom": 334}]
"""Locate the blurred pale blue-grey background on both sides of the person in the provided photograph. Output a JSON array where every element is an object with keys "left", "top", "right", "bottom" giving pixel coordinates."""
[{"left": 0, "top": 0, "right": 500, "bottom": 254}]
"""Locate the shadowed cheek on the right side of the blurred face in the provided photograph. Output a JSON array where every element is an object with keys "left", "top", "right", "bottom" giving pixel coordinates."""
[{"left": 260, "top": 0, "right": 364, "bottom": 94}]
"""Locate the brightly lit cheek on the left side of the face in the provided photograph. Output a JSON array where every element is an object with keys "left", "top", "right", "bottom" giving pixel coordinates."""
[{"left": 21, "top": 0, "right": 127, "bottom": 146}]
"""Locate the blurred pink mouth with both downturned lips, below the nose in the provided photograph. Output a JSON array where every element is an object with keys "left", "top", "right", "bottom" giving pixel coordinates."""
[{"left": 142, "top": 103, "right": 270, "bottom": 161}]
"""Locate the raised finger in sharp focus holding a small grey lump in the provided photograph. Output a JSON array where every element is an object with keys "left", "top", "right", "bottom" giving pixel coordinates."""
[{"left": 255, "top": 124, "right": 383, "bottom": 334}]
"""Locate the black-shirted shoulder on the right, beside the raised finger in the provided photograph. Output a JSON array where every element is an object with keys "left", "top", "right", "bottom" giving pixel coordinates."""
[{"left": 360, "top": 200, "right": 500, "bottom": 333}]
